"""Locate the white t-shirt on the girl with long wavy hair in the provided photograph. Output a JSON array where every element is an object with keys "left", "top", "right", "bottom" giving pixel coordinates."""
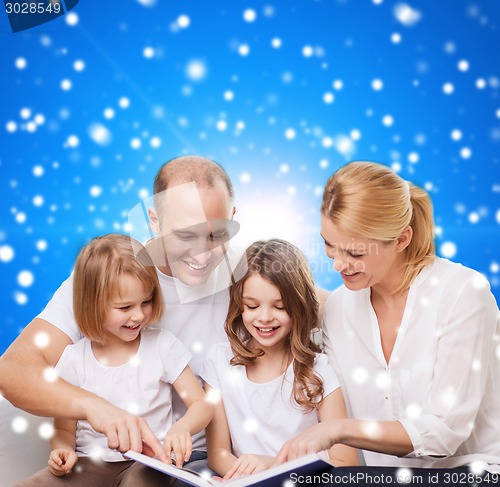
[{"left": 201, "top": 342, "right": 339, "bottom": 457}]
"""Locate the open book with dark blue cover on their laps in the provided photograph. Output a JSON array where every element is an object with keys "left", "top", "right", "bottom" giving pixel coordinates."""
[{"left": 124, "top": 450, "right": 333, "bottom": 487}]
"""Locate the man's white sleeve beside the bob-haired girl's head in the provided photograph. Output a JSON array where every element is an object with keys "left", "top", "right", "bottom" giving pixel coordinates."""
[{"left": 37, "top": 274, "right": 83, "bottom": 343}]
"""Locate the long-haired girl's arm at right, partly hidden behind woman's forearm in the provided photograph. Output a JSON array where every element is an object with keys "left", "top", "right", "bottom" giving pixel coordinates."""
[{"left": 318, "top": 387, "right": 359, "bottom": 467}]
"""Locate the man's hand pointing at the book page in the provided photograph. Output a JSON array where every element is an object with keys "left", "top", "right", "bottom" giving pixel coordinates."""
[{"left": 85, "top": 396, "right": 167, "bottom": 462}]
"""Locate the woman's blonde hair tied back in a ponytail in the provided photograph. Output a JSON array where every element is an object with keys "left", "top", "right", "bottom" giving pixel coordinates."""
[{"left": 321, "top": 162, "right": 435, "bottom": 291}]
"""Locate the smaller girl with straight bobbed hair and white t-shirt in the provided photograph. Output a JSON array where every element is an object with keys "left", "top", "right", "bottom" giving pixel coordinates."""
[{"left": 18, "top": 234, "right": 213, "bottom": 487}]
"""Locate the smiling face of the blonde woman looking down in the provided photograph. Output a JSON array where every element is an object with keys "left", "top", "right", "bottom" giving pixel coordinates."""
[{"left": 321, "top": 215, "right": 401, "bottom": 291}]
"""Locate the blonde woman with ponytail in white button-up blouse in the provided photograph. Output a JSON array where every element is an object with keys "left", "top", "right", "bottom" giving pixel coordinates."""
[{"left": 278, "top": 162, "right": 500, "bottom": 470}]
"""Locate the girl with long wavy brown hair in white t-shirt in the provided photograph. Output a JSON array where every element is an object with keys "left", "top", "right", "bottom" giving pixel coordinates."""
[{"left": 201, "top": 240, "right": 357, "bottom": 480}]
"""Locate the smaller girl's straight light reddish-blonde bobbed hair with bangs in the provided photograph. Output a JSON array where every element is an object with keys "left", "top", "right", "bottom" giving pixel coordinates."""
[{"left": 73, "top": 234, "right": 163, "bottom": 343}]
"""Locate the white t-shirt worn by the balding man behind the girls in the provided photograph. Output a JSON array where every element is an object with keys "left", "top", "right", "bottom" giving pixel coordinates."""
[{"left": 38, "top": 270, "right": 229, "bottom": 450}]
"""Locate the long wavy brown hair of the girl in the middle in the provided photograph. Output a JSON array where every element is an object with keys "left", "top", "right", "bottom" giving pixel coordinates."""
[{"left": 225, "top": 239, "right": 323, "bottom": 411}]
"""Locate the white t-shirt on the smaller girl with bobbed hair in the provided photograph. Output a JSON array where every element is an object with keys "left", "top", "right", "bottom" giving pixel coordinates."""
[{"left": 56, "top": 328, "right": 191, "bottom": 462}]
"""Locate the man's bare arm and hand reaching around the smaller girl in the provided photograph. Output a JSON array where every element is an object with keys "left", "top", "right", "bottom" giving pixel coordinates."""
[{"left": 0, "top": 318, "right": 168, "bottom": 459}]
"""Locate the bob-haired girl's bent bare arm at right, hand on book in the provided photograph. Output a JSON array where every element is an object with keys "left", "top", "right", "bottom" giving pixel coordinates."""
[{"left": 167, "top": 366, "right": 213, "bottom": 467}]
